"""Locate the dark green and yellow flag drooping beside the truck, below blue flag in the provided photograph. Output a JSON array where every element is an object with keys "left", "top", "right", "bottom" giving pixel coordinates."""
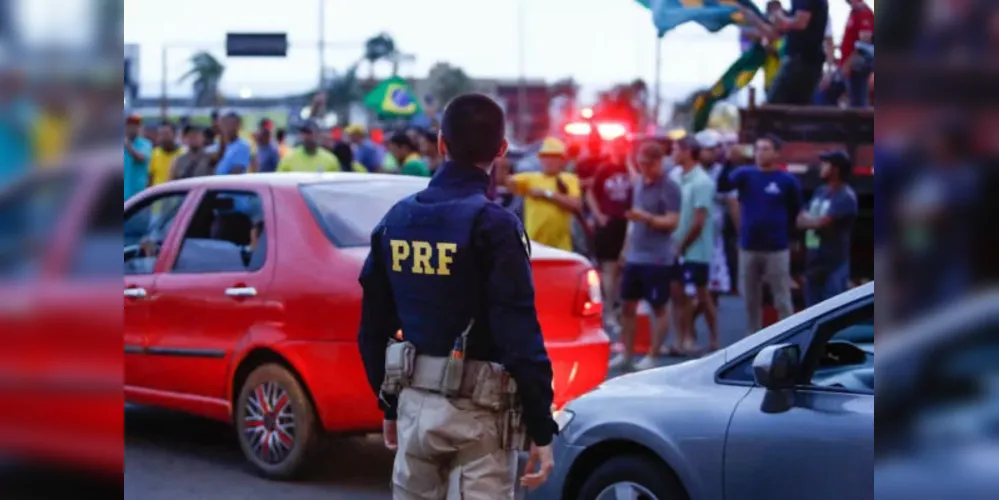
[{"left": 692, "top": 41, "right": 784, "bottom": 132}]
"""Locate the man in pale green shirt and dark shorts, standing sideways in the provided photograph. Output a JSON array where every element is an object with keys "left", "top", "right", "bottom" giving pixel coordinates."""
[{"left": 673, "top": 137, "right": 718, "bottom": 351}]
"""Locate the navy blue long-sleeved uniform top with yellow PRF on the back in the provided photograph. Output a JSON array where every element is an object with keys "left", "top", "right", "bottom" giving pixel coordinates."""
[{"left": 358, "top": 162, "right": 558, "bottom": 446}]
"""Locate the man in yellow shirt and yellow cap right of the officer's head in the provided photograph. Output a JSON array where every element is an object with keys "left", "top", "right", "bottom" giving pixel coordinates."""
[{"left": 505, "top": 138, "right": 582, "bottom": 252}]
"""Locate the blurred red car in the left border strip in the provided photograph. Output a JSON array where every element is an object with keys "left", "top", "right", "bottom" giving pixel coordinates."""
[{"left": 0, "top": 149, "right": 124, "bottom": 475}]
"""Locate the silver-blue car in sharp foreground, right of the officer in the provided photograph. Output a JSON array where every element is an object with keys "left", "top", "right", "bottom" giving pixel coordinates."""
[{"left": 531, "top": 283, "right": 874, "bottom": 500}]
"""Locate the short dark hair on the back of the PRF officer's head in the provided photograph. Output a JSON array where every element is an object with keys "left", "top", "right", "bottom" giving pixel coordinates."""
[{"left": 441, "top": 94, "right": 506, "bottom": 164}]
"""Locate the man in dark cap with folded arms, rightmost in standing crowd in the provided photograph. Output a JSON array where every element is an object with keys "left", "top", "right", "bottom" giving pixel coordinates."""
[{"left": 798, "top": 151, "right": 858, "bottom": 306}]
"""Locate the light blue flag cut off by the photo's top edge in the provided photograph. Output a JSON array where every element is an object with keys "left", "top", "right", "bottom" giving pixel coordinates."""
[{"left": 636, "top": 0, "right": 766, "bottom": 37}]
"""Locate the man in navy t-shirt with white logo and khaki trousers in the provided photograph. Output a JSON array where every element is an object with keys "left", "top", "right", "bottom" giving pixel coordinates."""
[{"left": 730, "top": 136, "right": 801, "bottom": 334}]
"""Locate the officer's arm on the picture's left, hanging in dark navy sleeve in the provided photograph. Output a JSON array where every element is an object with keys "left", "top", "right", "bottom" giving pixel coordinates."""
[{"left": 357, "top": 224, "right": 399, "bottom": 420}]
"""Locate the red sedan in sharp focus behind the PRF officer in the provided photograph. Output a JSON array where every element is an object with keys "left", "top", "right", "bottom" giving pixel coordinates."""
[{"left": 124, "top": 173, "right": 609, "bottom": 478}]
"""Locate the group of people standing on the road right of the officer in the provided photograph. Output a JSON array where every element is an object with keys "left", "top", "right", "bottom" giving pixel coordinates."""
[{"left": 498, "top": 130, "right": 858, "bottom": 369}]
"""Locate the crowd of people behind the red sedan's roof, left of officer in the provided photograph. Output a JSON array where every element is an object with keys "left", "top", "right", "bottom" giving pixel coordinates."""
[{"left": 124, "top": 112, "right": 442, "bottom": 200}]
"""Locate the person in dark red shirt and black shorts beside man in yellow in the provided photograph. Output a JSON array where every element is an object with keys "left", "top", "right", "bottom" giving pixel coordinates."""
[{"left": 585, "top": 143, "right": 632, "bottom": 332}]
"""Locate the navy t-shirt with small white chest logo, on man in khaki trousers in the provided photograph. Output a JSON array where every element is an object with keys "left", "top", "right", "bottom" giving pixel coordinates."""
[{"left": 730, "top": 166, "right": 801, "bottom": 252}]
